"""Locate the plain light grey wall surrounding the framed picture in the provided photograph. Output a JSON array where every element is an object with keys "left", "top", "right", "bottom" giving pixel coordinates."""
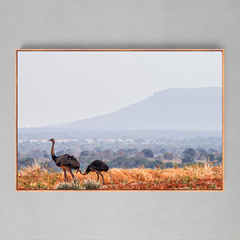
[{"left": 0, "top": 0, "right": 240, "bottom": 239}]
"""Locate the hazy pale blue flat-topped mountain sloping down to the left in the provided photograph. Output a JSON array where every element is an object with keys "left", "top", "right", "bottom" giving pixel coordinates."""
[{"left": 59, "top": 87, "right": 222, "bottom": 130}]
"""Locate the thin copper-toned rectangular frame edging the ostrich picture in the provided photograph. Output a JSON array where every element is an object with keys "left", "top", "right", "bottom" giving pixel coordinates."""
[{"left": 15, "top": 49, "right": 225, "bottom": 192}]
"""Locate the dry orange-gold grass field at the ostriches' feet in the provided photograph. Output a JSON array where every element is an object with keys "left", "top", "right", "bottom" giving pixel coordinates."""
[{"left": 17, "top": 163, "right": 223, "bottom": 190}]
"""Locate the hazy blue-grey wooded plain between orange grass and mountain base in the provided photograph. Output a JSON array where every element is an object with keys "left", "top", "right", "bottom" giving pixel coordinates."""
[{"left": 18, "top": 132, "right": 222, "bottom": 172}]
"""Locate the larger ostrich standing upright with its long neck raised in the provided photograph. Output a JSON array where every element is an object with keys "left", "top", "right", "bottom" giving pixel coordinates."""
[{"left": 48, "top": 138, "right": 82, "bottom": 182}]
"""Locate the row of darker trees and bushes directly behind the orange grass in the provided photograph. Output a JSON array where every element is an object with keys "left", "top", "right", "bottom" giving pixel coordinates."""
[{"left": 18, "top": 148, "right": 222, "bottom": 171}]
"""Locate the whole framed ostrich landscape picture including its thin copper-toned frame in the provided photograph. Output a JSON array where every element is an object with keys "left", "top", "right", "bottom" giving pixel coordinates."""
[{"left": 16, "top": 49, "right": 224, "bottom": 191}]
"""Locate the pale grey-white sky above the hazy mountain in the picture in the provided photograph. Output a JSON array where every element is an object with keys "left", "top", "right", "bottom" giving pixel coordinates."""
[{"left": 18, "top": 51, "right": 222, "bottom": 127}]
